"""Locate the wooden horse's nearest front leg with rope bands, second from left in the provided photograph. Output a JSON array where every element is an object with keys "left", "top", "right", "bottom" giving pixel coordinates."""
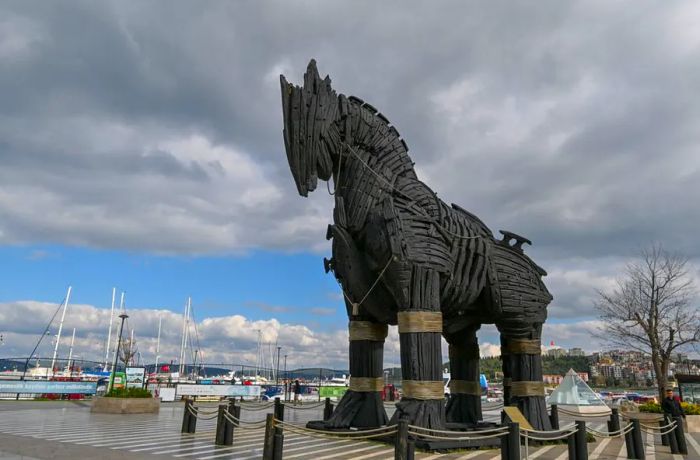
[{"left": 391, "top": 266, "right": 445, "bottom": 429}]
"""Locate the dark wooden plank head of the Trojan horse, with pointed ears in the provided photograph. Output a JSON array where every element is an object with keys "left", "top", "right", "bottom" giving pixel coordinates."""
[{"left": 280, "top": 59, "right": 342, "bottom": 196}]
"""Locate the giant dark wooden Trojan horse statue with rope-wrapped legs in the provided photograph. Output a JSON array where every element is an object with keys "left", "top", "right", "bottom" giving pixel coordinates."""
[{"left": 280, "top": 60, "right": 552, "bottom": 430}]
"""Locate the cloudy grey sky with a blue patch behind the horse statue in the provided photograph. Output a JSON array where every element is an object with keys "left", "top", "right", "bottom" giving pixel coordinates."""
[{"left": 0, "top": 0, "right": 700, "bottom": 367}]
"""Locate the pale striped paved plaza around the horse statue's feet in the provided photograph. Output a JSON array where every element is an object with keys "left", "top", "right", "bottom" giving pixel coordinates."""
[{"left": 0, "top": 401, "right": 700, "bottom": 460}]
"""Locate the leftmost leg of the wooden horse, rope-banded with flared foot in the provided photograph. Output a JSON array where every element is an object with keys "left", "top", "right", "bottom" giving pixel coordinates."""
[{"left": 314, "top": 309, "right": 388, "bottom": 428}]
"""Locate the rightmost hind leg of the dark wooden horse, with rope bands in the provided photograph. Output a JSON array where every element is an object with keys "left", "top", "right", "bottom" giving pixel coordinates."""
[{"left": 496, "top": 322, "right": 552, "bottom": 430}]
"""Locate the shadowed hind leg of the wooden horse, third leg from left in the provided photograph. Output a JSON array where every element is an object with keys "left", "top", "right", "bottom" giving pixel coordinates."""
[{"left": 445, "top": 325, "right": 482, "bottom": 424}]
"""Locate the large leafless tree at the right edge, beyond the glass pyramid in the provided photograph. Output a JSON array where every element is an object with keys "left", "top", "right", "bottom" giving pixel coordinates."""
[{"left": 596, "top": 245, "right": 700, "bottom": 400}]
